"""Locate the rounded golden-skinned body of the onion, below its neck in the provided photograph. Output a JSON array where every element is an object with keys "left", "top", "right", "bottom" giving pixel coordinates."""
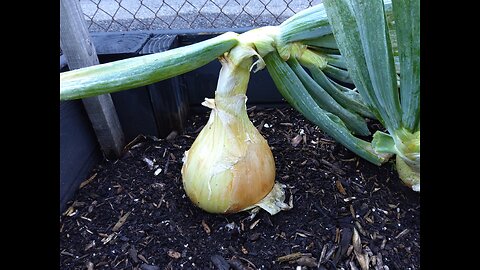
[{"left": 182, "top": 99, "right": 275, "bottom": 213}]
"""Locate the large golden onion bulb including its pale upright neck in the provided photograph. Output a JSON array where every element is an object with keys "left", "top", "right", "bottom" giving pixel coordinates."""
[{"left": 182, "top": 47, "right": 275, "bottom": 213}]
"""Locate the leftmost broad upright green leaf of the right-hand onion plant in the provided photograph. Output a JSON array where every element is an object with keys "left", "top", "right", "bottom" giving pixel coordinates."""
[{"left": 324, "top": 0, "right": 401, "bottom": 133}]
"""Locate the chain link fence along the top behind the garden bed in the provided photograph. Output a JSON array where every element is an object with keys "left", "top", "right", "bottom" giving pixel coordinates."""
[{"left": 79, "top": 0, "right": 322, "bottom": 32}]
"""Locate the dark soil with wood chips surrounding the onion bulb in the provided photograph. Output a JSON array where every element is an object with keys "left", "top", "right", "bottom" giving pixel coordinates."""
[{"left": 60, "top": 107, "right": 420, "bottom": 270}]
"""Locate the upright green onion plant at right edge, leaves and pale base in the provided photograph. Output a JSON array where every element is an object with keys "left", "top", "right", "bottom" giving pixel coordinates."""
[{"left": 325, "top": 0, "right": 420, "bottom": 191}]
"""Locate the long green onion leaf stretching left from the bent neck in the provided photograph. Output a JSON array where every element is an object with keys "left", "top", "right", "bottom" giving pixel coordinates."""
[{"left": 60, "top": 32, "right": 238, "bottom": 100}]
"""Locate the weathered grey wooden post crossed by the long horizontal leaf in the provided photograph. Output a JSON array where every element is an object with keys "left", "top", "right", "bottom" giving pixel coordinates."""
[{"left": 60, "top": 0, "right": 125, "bottom": 158}]
